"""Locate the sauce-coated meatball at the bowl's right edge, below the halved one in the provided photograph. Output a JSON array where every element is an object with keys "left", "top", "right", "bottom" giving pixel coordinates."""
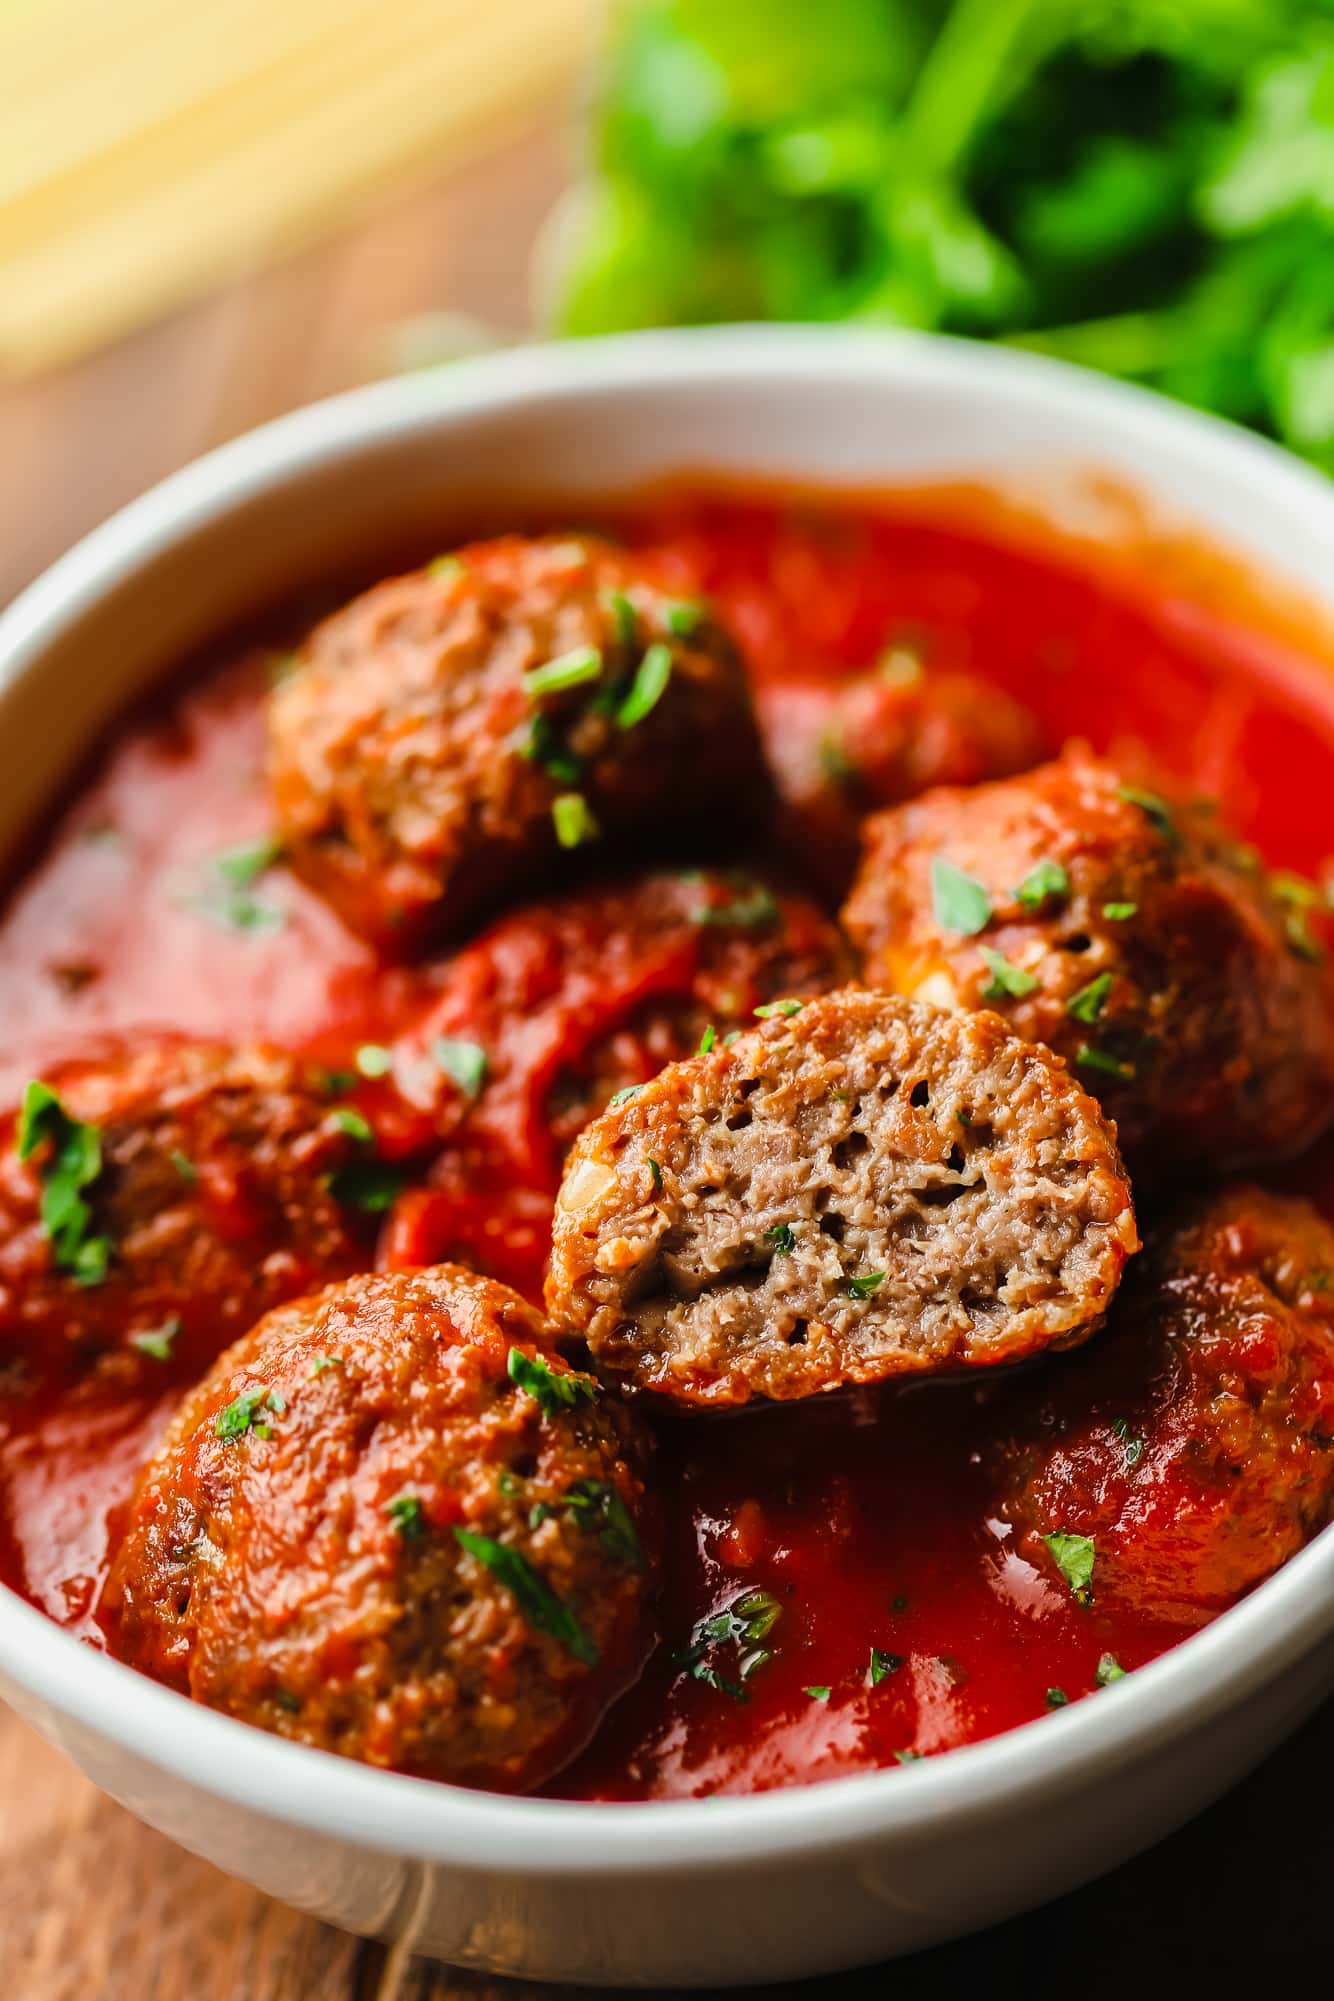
[{"left": 996, "top": 1187, "right": 1334, "bottom": 1625}]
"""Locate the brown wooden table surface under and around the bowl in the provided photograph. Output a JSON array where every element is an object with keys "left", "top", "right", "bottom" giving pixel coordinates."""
[{"left": 0, "top": 113, "right": 1334, "bottom": 2001}]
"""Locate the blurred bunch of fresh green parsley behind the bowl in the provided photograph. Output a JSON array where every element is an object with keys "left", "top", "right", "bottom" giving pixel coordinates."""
[{"left": 548, "top": 0, "right": 1334, "bottom": 470}]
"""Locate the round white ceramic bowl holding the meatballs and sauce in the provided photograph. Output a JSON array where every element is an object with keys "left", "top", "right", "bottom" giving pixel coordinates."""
[{"left": 0, "top": 328, "right": 1334, "bottom": 1985}]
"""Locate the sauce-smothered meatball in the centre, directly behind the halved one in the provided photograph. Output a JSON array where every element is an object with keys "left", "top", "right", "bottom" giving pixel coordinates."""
[{"left": 380, "top": 868, "right": 850, "bottom": 1293}]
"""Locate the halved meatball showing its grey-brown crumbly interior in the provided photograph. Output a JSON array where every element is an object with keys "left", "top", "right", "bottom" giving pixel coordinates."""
[{"left": 546, "top": 988, "right": 1138, "bottom": 1405}]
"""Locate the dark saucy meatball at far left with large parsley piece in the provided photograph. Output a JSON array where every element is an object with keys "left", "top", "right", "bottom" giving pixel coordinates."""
[{"left": 0, "top": 1045, "right": 376, "bottom": 1383}]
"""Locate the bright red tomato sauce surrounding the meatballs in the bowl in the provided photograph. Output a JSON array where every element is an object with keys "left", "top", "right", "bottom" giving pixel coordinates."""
[{"left": 0, "top": 496, "right": 1334, "bottom": 1799}]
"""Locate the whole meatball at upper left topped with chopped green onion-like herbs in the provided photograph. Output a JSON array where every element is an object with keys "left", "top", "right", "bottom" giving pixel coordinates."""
[{"left": 270, "top": 536, "right": 768, "bottom": 946}]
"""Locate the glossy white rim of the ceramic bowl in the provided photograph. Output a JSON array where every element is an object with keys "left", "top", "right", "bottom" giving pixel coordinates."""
[{"left": 0, "top": 326, "right": 1334, "bottom": 1879}]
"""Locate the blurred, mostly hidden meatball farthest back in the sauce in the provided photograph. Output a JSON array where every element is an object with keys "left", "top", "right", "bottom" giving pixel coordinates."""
[{"left": 758, "top": 648, "right": 1046, "bottom": 896}]
